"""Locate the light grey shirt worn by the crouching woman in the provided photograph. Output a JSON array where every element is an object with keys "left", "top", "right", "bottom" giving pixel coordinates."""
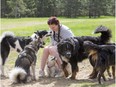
[{"left": 51, "top": 25, "right": 74, "bottom": 45}]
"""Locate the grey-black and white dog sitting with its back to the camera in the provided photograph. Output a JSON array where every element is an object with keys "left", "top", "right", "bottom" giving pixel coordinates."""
[{"left": 9, "top": 38, "right": 42, "bottom": 83}]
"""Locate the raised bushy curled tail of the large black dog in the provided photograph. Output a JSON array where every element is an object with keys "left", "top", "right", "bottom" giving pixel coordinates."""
[{"left": 94, "top": 25, "right": 112, "bottom": 44}]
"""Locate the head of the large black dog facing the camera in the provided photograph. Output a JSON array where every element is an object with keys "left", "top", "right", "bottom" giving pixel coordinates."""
[{"left": 57, "top": 38, "right": 79, "bottom": 59}]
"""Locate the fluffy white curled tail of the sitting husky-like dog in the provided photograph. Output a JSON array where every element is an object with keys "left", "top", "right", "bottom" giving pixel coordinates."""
[{"left": 9, "top": 67, "right": 27, "bottom": 83}]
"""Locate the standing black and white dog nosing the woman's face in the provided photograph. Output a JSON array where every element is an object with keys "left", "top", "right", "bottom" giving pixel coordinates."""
[{"left": 0, "top": 30, "right": 50, "bottom": 76}]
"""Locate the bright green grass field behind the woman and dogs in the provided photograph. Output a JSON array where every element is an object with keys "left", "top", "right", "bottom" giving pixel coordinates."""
[{"left": 1, "top": 17, "right": 115, "bottom": 41}]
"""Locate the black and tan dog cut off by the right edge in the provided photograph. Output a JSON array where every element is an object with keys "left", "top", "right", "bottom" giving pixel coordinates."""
[{"left": 84, "top": 41, "right": 116, "bottom": 84}]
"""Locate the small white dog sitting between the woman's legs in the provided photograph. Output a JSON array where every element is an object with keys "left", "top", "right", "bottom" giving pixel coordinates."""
[{"left": 46, "top": 56, "right": 61, "bottom": 77}]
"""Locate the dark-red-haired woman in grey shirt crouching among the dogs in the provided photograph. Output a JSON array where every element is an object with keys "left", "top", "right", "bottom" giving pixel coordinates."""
[{"left": 39, "top": 17, "right": 74, "bottom": 77}]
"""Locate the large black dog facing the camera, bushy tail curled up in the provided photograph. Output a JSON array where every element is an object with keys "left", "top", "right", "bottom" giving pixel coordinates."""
[{"left": 57, "top": 26, "right": 111, "bottom": 79}]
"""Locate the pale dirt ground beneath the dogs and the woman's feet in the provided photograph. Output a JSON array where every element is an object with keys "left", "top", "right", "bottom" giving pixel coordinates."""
[{"left": 0, "top": 60, "right": 115, "bottom": 87}]
